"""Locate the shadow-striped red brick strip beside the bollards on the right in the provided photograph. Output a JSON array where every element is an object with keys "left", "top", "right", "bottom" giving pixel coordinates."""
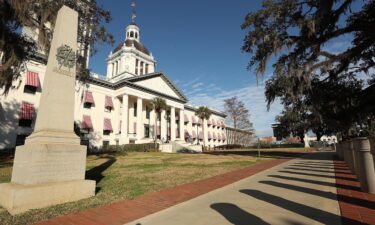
[{"left": 333, "top": 160, "right": 375, "bottom": 224}]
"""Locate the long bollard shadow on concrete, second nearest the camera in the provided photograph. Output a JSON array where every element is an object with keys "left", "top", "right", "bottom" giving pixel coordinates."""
[{"left": 240, "top": 189, "right": 358, "bottom": 224}]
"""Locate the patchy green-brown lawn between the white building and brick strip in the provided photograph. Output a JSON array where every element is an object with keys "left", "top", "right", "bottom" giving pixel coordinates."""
[{"left": 0, "top": 149, "right": 282, "bottom": 225}]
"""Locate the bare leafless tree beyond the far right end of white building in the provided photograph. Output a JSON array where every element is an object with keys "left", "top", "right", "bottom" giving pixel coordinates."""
[{"left": 224, "top": 97, "right": 253, "bottom": 143}]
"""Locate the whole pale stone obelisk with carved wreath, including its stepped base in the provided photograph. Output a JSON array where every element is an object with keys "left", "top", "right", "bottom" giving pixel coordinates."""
[{"left": 0, "top": 6, "right": 95, "bottom": 214}]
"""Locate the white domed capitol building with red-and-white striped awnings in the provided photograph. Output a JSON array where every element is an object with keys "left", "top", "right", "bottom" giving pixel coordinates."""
[{"left": 0, "top": 18, "right": 253, "bottom": 149}]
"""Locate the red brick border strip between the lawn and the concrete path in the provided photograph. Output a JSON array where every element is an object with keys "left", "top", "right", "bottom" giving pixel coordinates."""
[{"left": 37, "top": 154, "right": 297, "bottom": 225}]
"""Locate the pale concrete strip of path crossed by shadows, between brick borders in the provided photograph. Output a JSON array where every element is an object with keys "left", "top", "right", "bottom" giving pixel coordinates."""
[{"left": 128, "top": 152, "right": 346, "bottom": 225}]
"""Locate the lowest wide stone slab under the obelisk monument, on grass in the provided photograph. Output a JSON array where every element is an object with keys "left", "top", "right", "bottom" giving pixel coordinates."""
[{"left": 0, "top": 180, "right": 95, "bottom": 215}]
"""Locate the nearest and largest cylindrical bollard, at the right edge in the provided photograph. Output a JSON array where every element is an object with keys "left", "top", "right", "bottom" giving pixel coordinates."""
[{"left": 354, "top": 137, "right": 375, "bottom": 194}]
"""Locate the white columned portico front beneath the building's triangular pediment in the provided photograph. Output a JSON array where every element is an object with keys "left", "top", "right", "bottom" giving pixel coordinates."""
[{"left": 114, "top": 91, "right": 184, "bottom": 144}]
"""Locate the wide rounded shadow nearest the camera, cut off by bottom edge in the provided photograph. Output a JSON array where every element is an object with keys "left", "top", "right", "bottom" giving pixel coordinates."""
[{"left": 210, "top": 203, "right": 269, "bottom": 225}]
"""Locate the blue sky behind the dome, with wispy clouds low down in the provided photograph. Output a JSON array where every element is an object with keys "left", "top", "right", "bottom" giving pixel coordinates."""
[{"left": 90, "top": 0, "right": 281, "bottom": 136}]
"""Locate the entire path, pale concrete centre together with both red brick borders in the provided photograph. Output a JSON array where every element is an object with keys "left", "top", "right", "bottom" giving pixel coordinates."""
[{"left": 38, "top": 152, "right": 375, "bottom": 225}]
